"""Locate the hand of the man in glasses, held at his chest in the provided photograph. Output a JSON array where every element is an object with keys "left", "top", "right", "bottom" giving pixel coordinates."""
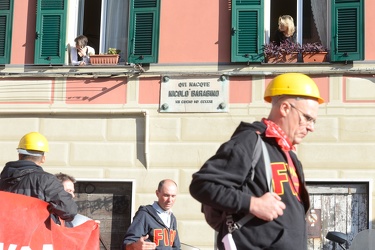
[{"left": 250, "top": 193, "right": 285, "bottom": 221}]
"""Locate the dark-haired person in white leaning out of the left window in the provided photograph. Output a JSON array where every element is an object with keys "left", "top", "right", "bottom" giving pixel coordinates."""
[{"left": 70, "top": 35, "right": 95, "bottom": 66}]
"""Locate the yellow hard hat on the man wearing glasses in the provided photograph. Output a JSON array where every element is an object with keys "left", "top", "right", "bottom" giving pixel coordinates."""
[{"left": 264, "top": 73, "right": 324, "bottom": 104}]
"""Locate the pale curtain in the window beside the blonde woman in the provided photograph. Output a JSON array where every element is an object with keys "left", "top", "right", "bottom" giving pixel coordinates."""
[{"left": 311, "top": 0, "right": 327, "bottom": 47}]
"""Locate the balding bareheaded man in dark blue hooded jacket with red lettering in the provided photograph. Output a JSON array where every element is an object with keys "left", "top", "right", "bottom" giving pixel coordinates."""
[{"left": 123, "top": 179, "right": 181, "bottom": 250}]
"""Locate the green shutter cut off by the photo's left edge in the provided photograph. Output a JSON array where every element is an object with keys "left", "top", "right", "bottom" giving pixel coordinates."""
[{"left": 0, "top": 0, "right": 13, "bottom": 64}]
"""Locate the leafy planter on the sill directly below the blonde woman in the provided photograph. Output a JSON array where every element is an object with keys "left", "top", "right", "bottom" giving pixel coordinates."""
[{"left": 263, "top": 41, "right": 301, "bottom": 63}]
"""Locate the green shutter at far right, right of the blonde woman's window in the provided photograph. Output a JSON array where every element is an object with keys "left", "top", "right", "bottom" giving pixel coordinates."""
[{"left": 331, "top": 0, "right": 364, "bottom": 61}]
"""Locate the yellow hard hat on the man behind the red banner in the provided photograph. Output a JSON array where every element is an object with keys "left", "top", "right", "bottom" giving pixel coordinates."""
[{"left": 17, "top": 132, "right": 49, "bottom": 155}]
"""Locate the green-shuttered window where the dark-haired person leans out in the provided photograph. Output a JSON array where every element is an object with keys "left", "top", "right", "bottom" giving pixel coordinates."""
[{"left": 33, "top": 0, "right": 160, "bottom": 64}]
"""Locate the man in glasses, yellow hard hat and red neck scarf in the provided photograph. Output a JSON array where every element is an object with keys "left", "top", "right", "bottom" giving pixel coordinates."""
[{"left": 190, "top": 73, "right": 324, "bottom": 250}]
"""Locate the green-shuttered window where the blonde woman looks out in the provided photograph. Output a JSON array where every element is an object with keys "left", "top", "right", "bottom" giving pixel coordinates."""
[{"left": 232, "top": 0, "right": 364, "bottom": 62}]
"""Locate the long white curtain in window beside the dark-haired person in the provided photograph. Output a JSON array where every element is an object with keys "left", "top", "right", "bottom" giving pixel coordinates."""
[{"left": 102, "top": 0, "right": 129, "bottom": 61}]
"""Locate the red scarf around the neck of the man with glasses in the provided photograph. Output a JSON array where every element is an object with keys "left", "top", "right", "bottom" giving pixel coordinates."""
[{"left": 262, "top": 118, "right": 301, "bottom": 201}]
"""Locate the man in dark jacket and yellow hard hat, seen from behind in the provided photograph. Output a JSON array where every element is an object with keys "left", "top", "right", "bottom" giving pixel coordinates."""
[{"left": 0, "top": 132, "right": 77, "bottom": 221}]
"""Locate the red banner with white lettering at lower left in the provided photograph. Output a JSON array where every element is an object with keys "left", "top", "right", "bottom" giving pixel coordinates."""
[{"left": 0, "top": 191, "right": 99, "bottom": 250}]
